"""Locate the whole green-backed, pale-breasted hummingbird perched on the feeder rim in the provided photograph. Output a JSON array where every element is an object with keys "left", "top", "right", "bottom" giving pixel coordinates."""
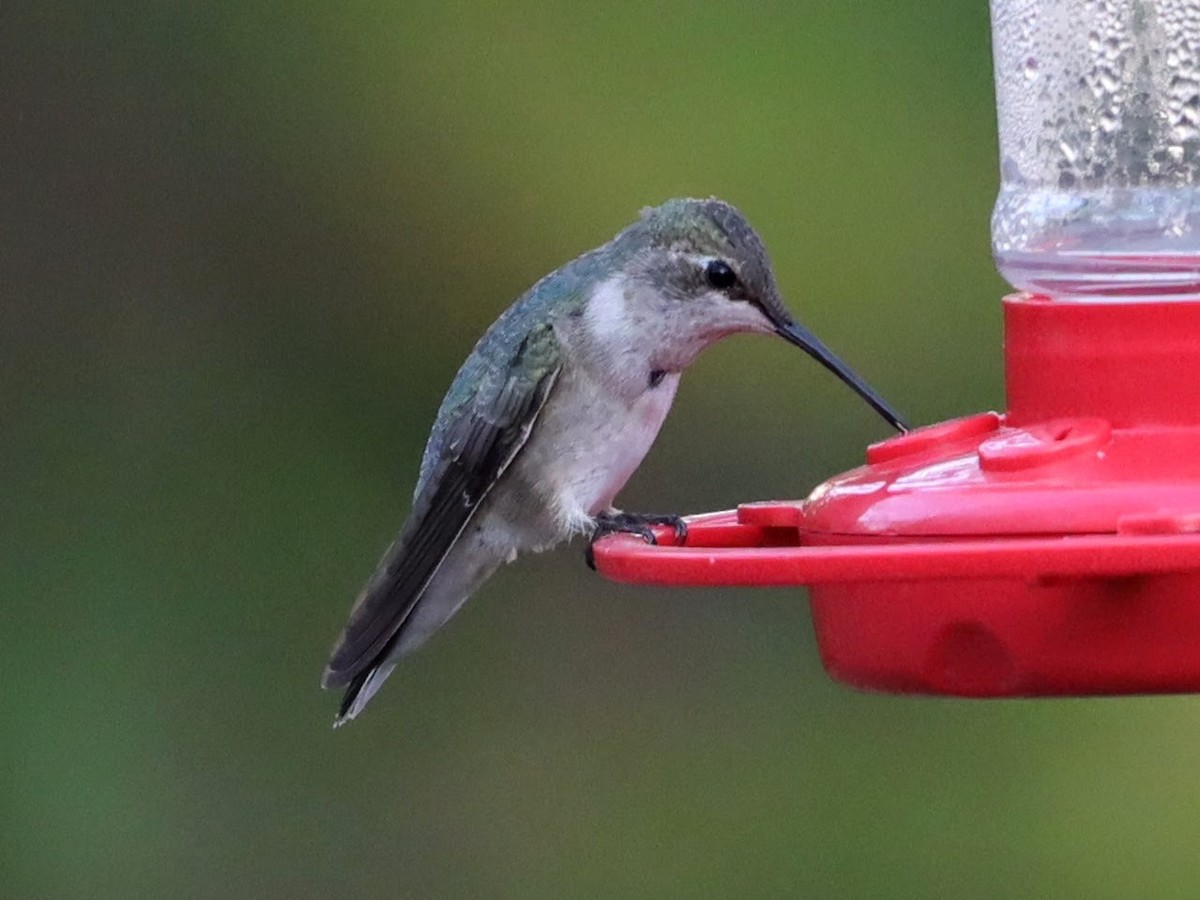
[{"left": 322, "top": 198, "right": 906, "bottom": 727}]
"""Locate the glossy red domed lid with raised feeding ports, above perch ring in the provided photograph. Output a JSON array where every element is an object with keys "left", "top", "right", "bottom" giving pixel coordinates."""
[{"left": 803, "top": 413, "right": 1200, "bottom": 536}]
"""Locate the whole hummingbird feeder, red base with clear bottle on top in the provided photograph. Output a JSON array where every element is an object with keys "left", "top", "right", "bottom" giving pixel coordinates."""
[{"left": 594, "top": 0, "right": 1200, "bottom": 697}]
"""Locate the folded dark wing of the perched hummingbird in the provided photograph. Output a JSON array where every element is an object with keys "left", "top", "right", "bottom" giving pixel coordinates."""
[{"left": 322, "top": 318, "right": 560, "bottom": 706}]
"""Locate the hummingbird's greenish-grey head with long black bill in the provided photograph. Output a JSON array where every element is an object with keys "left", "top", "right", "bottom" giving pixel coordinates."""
[{"left": 617, "top": 198, "right": 906, "bottom": 431}]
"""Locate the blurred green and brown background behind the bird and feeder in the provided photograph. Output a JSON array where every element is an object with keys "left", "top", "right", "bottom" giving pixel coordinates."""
[{"left": 0, "top": 0, "right": 1200, "bottom": 898}]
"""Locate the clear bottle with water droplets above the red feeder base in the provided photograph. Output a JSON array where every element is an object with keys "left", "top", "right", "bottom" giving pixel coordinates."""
[{"left": 991, "top": 0, "right": 1200, "bottom": 300}]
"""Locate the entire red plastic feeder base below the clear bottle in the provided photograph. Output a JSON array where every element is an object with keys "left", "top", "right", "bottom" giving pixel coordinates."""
[{"left": 595, "top": 295, "right": 1200, "bottom": 697}]
